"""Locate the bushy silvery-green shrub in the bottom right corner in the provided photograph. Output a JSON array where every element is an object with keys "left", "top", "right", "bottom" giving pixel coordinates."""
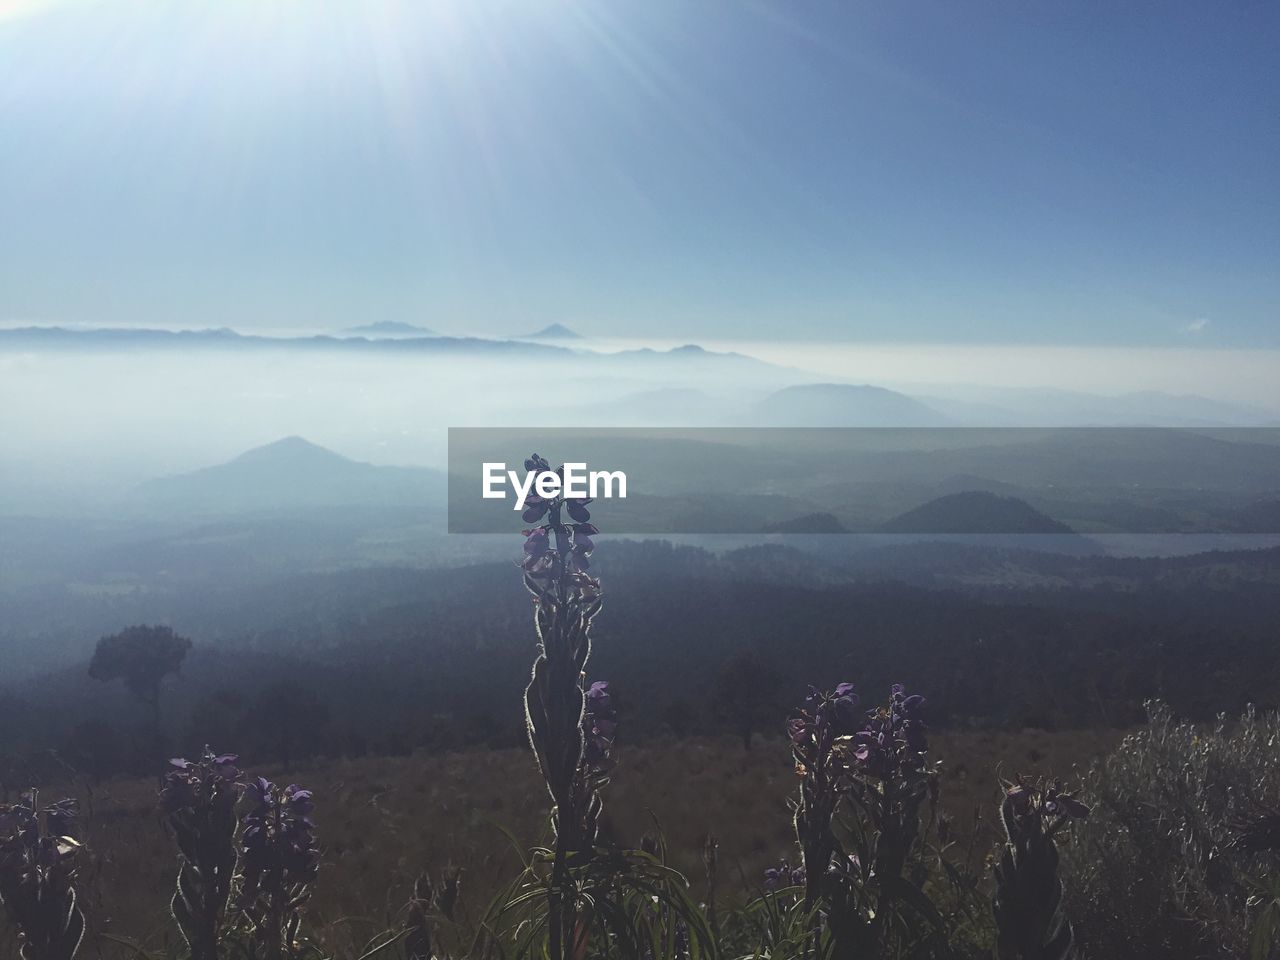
[{"left": 1065, "top": 703, "right": 1280, "bottom": 960}]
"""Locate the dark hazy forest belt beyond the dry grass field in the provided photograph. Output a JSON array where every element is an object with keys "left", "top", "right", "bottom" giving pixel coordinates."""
[{"left": 10, "top": 542, "right": 1280, "bottom": 783}]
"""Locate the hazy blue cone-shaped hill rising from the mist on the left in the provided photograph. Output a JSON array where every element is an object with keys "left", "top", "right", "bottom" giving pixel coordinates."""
[{"left": 132, "top": 436, "right": 445, "bottom": 516}]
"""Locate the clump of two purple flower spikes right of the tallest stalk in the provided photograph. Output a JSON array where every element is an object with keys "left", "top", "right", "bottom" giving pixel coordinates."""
[{"left": 762, "top": 682, "right": 974, "bottom": 957}]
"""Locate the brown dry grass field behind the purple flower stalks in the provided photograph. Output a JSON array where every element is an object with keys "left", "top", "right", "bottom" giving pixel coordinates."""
[{"left": 0, "top": 731, "right": 1119, "bottom": 957}]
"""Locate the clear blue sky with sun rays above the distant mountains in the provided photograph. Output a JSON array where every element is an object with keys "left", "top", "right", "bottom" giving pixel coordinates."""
[{"left": 0, "top": 0, "right": 1280, "bottom": 347}]
